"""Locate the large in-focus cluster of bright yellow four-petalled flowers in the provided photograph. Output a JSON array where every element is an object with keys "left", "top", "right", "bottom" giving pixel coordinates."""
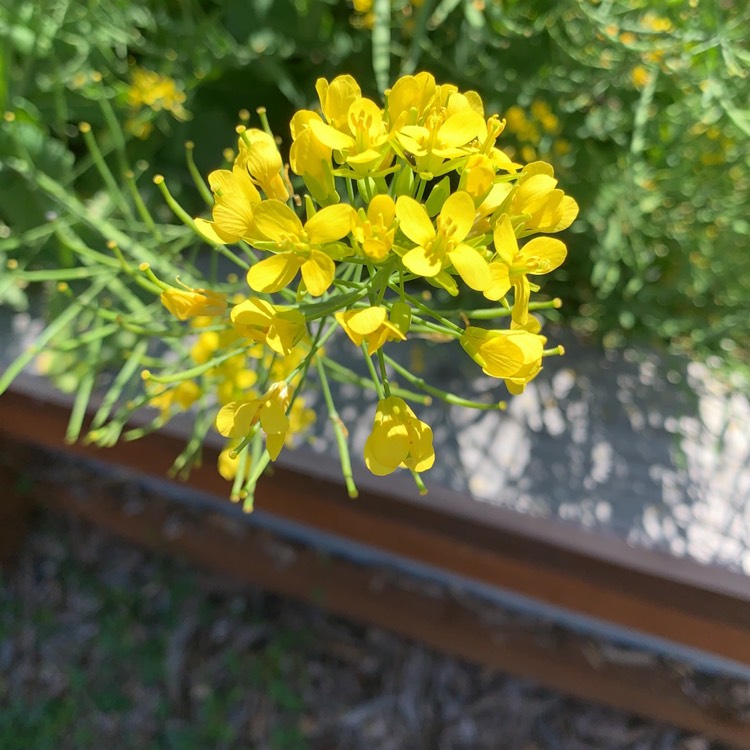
[{"left": 150, "top": 73, "right": 578, "bottom": 506}]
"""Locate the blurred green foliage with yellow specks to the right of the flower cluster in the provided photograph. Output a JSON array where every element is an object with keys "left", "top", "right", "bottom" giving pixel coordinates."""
[{"left": 354, "top": 0, "right": 750, "bottom": 368}]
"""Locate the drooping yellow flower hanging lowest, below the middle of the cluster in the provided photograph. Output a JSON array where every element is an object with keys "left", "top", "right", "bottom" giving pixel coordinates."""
[{"left": 365, "top": 396, "right": 435, "bottom": 476}]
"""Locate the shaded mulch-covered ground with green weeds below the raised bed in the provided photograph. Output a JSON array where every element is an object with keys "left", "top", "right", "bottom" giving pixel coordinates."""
[{"left": 0, "top": 500, "right": 748, "bottom": 750}]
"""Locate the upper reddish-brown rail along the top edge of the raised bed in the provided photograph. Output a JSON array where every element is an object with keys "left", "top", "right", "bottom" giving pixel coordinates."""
[{"left": 0, "top": 384, "right": 750, "bottom": 665}]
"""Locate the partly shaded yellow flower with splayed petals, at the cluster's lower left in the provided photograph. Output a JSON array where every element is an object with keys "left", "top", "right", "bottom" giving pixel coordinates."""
[{"left": 216, "top": 382, "right": 292, "bottom": 461}]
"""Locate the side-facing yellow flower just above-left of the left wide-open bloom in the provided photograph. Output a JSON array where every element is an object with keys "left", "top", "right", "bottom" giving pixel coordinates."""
[{"left": 195, "top": 166, "right": 261, "bottom": 245}]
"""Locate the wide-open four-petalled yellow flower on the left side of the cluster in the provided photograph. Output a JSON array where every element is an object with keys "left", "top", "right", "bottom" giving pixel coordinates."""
[{"left": 247, "top": 200, "right": 355, "bottom": 297}]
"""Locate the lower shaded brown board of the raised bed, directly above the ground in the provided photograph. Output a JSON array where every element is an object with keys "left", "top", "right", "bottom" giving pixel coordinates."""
[{"left": 10, "top": 452, "right": 750, "bottom": 747}]
